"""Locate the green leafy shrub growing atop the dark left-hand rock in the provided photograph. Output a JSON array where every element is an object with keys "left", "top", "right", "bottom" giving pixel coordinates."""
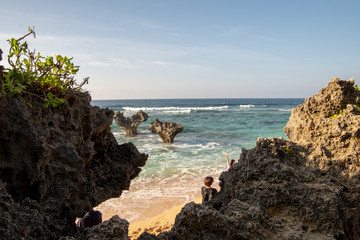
[{"left": 1, "top": 28, "right": 88, "bottom": 108}]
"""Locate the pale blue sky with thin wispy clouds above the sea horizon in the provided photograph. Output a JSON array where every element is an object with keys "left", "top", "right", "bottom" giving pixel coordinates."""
[{"left": 0, "top": 0, "right": 360, "bottom": 99}]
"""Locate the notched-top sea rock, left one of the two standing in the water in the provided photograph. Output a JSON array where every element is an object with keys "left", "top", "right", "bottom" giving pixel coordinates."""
[{"left": 115, "top": 110, "right": 149, "bottom": 136}]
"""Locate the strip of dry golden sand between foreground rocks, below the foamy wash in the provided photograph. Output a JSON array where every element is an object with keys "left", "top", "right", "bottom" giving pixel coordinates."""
[{"left": 129, "top": 196, "right": 201, "bottom": 239}]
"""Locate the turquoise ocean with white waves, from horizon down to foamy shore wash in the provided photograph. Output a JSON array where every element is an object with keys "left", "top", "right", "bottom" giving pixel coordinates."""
[{"left": 91, "top": 98, "right": 304, "bottom": 222}]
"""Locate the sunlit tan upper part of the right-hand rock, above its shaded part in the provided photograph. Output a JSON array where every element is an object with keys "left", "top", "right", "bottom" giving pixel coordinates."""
[{"left": 284, "top": 78, "right": 360, "bottom": 177}]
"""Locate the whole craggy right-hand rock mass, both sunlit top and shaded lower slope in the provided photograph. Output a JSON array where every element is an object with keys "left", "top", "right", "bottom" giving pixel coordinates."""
[{"left": 138, "top": 79, "right": 360, "bottom": 240}]
